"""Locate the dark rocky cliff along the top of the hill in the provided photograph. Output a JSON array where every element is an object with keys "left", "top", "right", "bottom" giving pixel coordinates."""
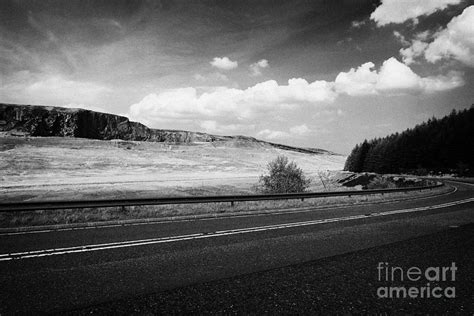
[{"left": 0, "top": 103, "right": 329, "bottom": 154}]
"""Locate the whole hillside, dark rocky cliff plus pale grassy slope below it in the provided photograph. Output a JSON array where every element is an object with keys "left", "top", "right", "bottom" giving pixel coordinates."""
[{"left": 0, "top": 104, "right": 346, "bottom": 200}]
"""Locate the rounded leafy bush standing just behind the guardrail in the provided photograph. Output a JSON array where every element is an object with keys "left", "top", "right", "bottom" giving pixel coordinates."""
[{"left": 259, "top": 156, "right": 311, "bottom": 193}]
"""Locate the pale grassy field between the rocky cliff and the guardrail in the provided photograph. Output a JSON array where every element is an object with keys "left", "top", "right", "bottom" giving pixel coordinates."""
[{"left": 0, "top": 137, "right": 346, "bottom": 201}]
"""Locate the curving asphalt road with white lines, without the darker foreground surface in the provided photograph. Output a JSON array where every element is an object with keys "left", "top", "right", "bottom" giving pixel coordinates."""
[{"left": 0, "top": 183, "right": 474, "bottom": 314}]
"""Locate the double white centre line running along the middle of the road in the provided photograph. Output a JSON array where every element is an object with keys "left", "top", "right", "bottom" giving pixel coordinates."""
[{"left": 0, "top": 198, "right": 474, "bottom": 261}]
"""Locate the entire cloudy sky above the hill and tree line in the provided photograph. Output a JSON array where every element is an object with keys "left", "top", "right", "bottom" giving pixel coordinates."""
[{"left": 0, "top": 0, "right": 474, "bottom": 154}]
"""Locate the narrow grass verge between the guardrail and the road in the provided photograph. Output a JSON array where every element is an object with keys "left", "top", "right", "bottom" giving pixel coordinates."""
[{"left": 0, "top": 186, "right": 452, "bottom": 228}]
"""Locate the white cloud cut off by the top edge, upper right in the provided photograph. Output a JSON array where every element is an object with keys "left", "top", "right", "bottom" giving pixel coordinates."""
[{"left": 370, "top": 0, "right": 462, "bottom": 26}]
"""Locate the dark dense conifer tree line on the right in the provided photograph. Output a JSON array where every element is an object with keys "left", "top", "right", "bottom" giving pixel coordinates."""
[{"left": 344, "top": 105, "right": 474, "bottom": 175}]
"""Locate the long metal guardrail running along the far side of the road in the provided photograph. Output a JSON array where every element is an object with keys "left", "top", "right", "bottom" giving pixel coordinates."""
[{"left": 0, "top": 182, "right": 444, "bottom": 212}]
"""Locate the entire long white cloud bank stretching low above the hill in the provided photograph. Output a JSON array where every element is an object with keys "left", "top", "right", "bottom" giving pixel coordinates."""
[{"left": 127, "top": 57, "right": 464, "bottom": 139}]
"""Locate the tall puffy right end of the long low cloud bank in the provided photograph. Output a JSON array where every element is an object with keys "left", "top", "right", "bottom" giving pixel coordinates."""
[{"left": 335, "top": 57, "right": 464, "bottom": 96}]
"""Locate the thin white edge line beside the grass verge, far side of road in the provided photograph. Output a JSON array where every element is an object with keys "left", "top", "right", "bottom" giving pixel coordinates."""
[{"left": 0, "top": 182, "right": 460, "bottom": 236}]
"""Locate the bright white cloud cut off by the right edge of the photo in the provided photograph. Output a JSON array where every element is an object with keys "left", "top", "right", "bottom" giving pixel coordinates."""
[{"left": 425, "top": 6, "right": 474, "bottom": 67}]
